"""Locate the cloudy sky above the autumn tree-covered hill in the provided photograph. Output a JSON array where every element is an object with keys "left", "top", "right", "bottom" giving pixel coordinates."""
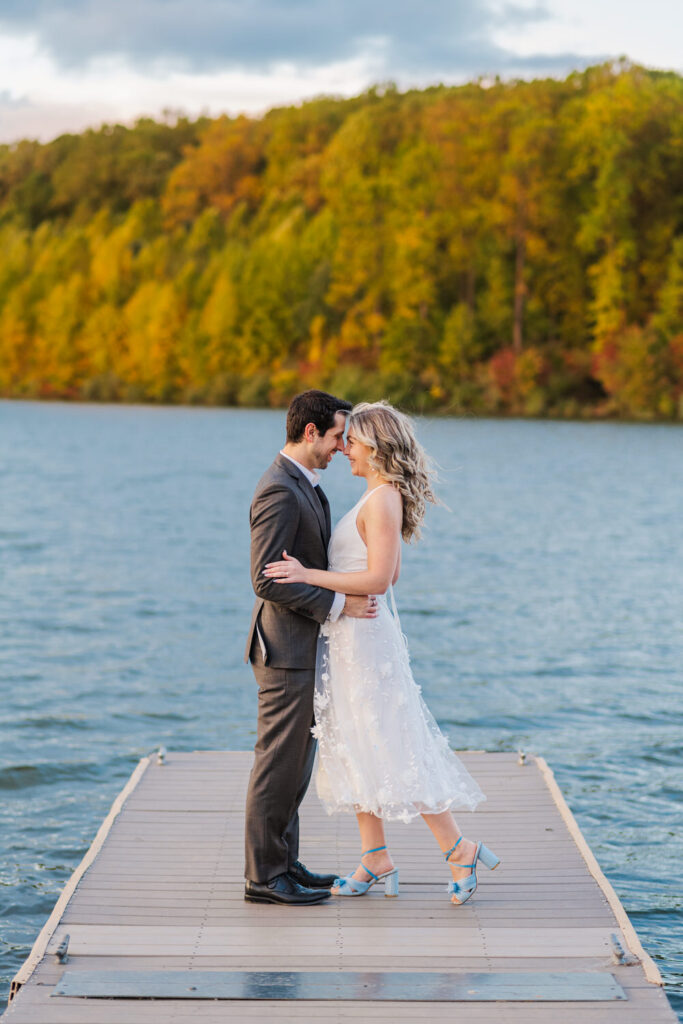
[{"left": 0, "top": 0, "right": 683, "bottom": 142}]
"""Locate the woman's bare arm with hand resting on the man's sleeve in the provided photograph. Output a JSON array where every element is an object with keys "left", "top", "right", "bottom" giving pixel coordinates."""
[{"left": 263, "top": 487, "right": 402, "bottom": 595}]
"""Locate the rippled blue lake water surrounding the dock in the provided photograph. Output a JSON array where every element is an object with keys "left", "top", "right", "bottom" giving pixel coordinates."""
[{"left": 0, "top": 402, "right": 683, "bottom": 1019}]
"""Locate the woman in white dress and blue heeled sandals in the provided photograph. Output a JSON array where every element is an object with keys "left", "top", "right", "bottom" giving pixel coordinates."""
[{"left": 264, "top": 401, "right": 500, "bottom": 904}]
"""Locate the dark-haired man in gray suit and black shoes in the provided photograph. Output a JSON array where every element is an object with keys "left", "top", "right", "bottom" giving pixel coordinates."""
[{"left": 245, "top": 391, "right": 377, "bottom": 905}]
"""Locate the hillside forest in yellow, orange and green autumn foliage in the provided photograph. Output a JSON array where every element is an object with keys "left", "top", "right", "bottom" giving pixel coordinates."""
[{"left": 0, "top": 61, "right": 683, "bottom": 420}]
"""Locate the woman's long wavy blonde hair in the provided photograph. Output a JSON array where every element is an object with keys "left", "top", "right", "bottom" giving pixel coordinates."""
[{"left": 348, "top": 400, "right": 438, "bottom": 541}]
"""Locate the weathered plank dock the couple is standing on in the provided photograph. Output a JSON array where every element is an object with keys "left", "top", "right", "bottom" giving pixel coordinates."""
[{"left": 2, "top": 752, "right": 676, "bottom": 1024}]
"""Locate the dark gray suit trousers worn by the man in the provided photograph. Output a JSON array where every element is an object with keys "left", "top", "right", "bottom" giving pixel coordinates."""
[{"left": 245, "top": 638, "right": 316, "bottom": 883}]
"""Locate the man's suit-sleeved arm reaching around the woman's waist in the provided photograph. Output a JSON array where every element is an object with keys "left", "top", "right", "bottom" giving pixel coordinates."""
[{"left": 251, "top": 484, "right": 335, "bottom": 624}]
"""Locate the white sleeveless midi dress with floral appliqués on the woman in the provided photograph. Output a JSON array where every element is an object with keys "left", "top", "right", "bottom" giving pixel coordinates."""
[{"left": 313, "top": 488, "right": 486, "bottom": 821}]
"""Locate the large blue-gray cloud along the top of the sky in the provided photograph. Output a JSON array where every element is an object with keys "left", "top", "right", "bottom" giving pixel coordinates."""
[{"left": 0, "top": 0, "right": 547, "bottom": 73}]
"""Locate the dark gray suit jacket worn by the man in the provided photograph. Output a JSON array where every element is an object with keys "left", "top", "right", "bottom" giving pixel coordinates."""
[{"left": 245, "top": 455, "right": 335, "bottom": 670}]
